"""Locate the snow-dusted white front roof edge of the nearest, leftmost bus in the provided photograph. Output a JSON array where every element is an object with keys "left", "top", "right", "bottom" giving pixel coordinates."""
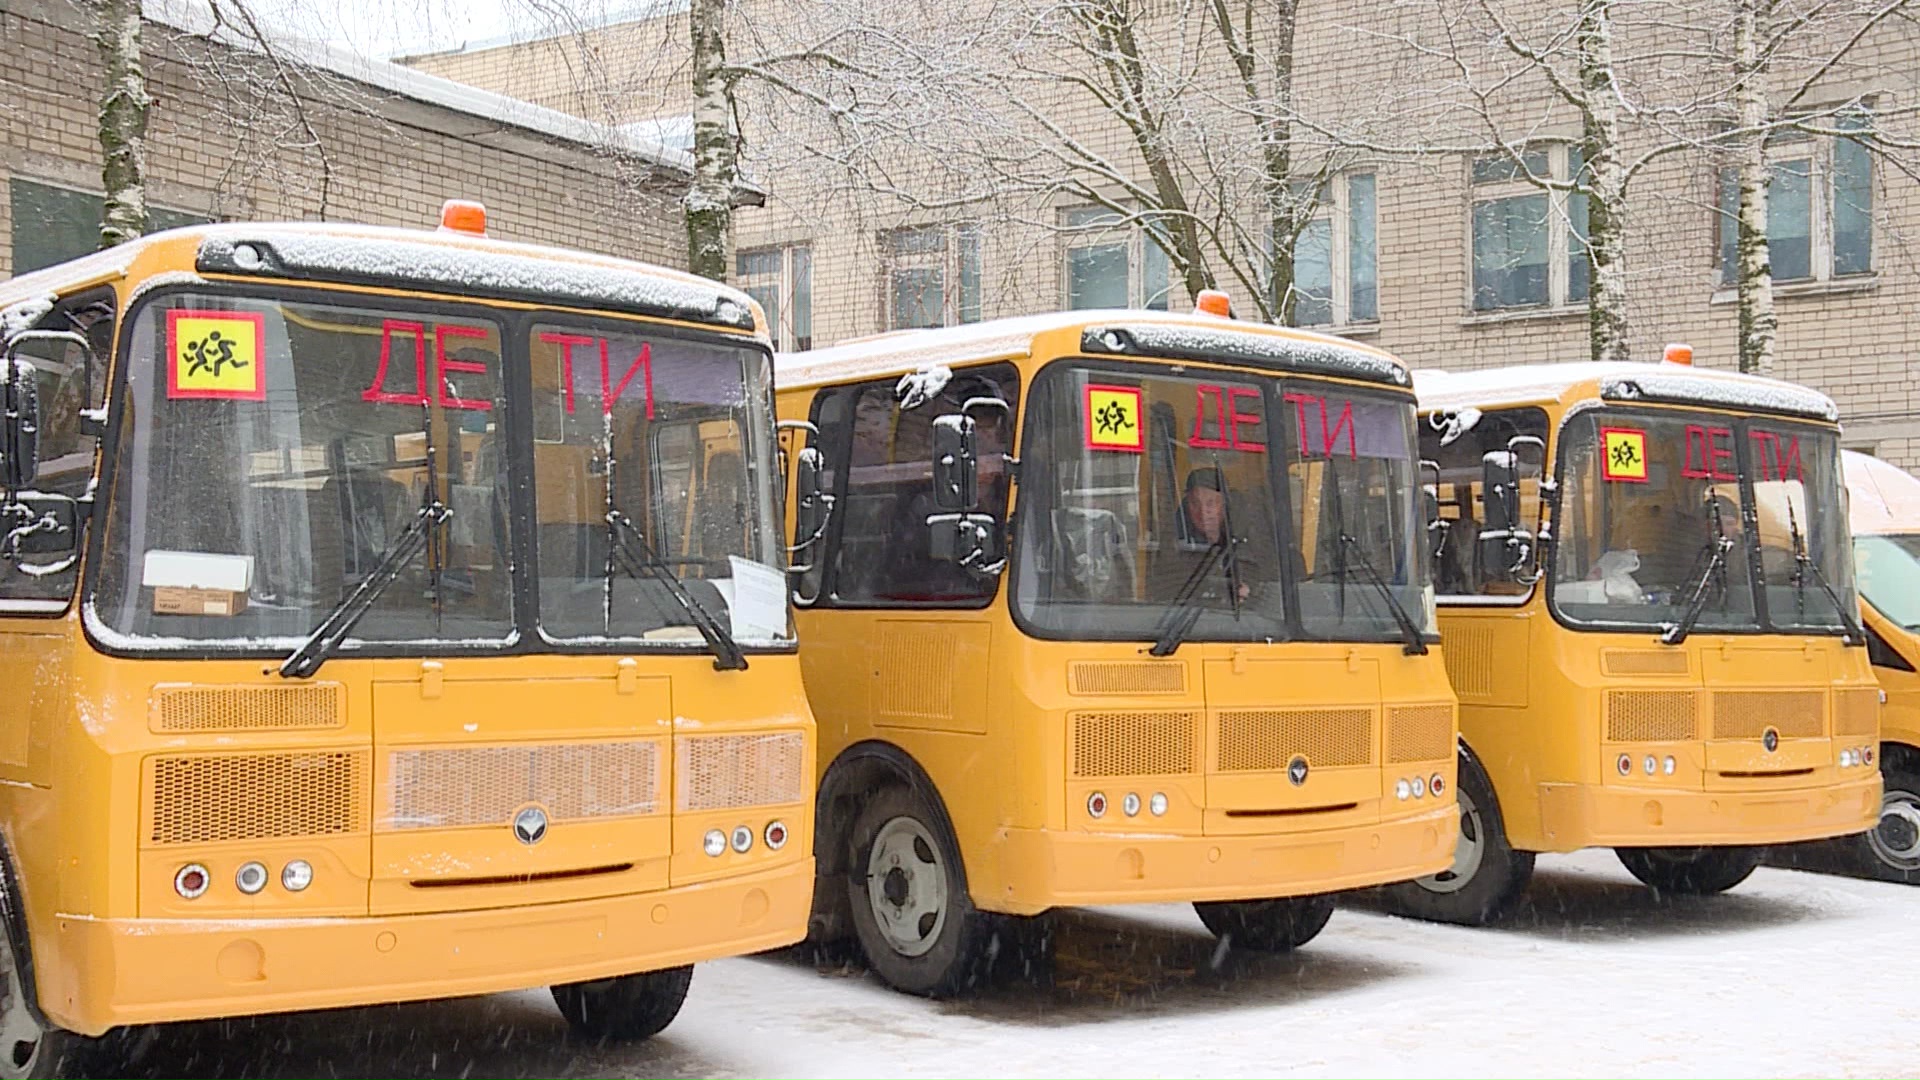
[{"left": 0, "top": 221, "right": 766, "bottom": 331}]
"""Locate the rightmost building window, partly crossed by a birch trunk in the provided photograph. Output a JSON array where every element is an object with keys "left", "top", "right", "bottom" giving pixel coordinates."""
[{"left": 1715, "top": 111, "right": 1874, "bottom": 286}]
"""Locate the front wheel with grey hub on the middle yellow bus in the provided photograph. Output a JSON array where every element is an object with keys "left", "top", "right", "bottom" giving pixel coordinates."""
[{"left": 847, "top": 786, "right": 1023, "bottom": 997}]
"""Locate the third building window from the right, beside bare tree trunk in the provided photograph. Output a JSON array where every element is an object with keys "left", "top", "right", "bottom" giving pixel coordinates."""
[{"left": 1273, "top": 173, "right": 1380, "bottom": 327}]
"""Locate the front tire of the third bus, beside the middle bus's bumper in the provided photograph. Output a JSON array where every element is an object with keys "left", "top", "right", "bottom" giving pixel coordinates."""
[{"left": 1380, "top": 737, "right": 1534, "bottom": 926}]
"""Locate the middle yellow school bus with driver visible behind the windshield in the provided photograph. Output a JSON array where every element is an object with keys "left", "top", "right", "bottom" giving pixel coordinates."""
[{"left": 778, "top": 294, "right": 1457, "bottom": 995}]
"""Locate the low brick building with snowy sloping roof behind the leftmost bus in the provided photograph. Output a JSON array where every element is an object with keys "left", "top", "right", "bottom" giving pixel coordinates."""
[{"left": 0, "top": 0, "right": 706, "bottom": 282}]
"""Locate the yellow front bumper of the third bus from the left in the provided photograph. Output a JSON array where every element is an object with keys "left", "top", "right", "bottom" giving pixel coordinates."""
[{"left": 1540, "top": 774, "right": 1880, "bottom": 851}]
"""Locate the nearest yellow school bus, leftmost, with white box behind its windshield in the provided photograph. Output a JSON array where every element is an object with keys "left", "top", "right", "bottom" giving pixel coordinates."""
[{"left": 0, "top": 204, "right": 814, "bottom": 1076}]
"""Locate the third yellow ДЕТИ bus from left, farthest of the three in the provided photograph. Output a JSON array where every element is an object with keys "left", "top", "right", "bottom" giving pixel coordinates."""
[{"left": 1388, "top": 357, "right": 1880, "bottom": 924}]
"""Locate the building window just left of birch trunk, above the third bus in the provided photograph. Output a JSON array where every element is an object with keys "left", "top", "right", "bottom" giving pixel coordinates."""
[{"left": 1471, "top": 144, "right": 1590, "bottom": 311}]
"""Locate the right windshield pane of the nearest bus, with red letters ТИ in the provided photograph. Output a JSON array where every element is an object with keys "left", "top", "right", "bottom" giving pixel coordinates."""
[{"left": 530, "top": 321, "right": 787, "bottom": 648}]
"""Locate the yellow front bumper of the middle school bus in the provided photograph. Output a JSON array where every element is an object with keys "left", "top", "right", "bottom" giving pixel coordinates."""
[{"left": 973, "top": 799, "right": 1459, "bottom": 915}]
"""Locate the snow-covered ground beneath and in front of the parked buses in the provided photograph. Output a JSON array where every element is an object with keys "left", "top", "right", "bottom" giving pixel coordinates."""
[{"left": 150, "top": 851, "right": 1920, "bottom": 1080}]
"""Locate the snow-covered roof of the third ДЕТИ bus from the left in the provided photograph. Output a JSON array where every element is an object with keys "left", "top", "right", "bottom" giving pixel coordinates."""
[{"left": 1413, "top": 361, "right": 1839, "bottom": 421}]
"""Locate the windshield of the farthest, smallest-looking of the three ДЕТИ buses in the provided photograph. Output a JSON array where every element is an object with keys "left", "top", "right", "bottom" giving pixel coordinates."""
[{"left": 1553, "top": 409, "right": 1855, "bottom": 632}]
